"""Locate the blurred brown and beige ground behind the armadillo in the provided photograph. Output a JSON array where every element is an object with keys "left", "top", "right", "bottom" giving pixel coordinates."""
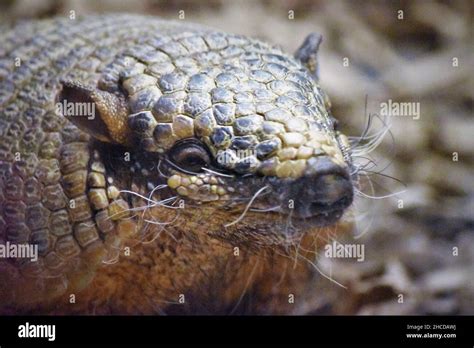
[{"left": 0, "top": 0, "right": 474, "bottom": 314}]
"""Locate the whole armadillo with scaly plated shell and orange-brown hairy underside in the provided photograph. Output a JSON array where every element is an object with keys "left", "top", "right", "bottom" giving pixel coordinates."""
[{"left": 0, "top": 16, "right": 353, "bottom": 314}]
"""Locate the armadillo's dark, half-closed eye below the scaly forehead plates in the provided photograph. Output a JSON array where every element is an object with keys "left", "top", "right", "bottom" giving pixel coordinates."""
[{"left": 168, "top": 140, "right": 211, "bottom": 173}]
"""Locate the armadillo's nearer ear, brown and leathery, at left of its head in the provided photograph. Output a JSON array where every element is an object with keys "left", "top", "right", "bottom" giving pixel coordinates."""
[{"left": 56, "top": 81, "right": 130, "bottom": 145}]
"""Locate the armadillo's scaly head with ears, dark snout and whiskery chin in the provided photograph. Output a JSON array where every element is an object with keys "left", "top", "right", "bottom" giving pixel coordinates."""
[{"left": 59, "top": 33, "right": 353, "bottom": 245}]
